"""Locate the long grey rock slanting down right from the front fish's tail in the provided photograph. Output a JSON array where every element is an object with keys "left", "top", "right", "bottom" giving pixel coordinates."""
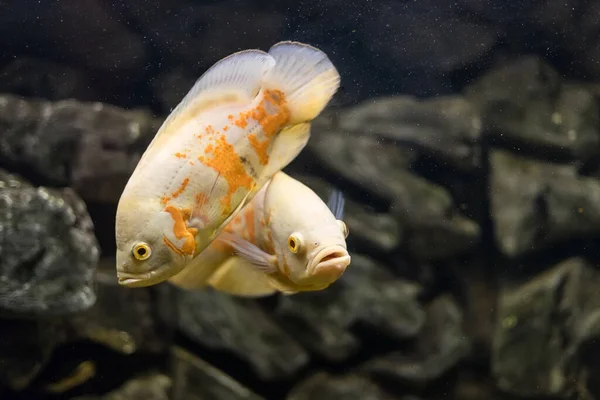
[{"left": 307, "top": 126, "right": 480, "bottom": 259}]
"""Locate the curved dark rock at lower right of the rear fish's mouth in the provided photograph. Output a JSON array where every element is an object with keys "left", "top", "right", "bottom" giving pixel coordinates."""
[{"left": 363, "top": 295, "right": 471, "bottom": 386}]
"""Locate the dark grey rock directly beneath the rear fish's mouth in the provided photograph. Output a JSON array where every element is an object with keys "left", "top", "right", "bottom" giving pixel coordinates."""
[{"left": 275, "top": 253, "right": 425, "bottom": 362}]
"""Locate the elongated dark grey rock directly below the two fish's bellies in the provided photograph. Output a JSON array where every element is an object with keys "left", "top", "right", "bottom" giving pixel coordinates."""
[{"left": 172, "top": 288, "right": 308, "bottom": 381}]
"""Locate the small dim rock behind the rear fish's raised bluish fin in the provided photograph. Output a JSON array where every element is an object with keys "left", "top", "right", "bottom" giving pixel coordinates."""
[{"left": 292, "top": 174, "right": 401, "bottom": 253}]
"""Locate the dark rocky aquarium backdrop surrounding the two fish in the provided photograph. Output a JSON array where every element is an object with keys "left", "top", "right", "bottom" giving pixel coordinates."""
[{"left": 0, "top": 0, "right": 600, "bottom": 400}]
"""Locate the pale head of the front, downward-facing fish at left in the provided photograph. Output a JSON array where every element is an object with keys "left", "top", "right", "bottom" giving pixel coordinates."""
[{"left": 115, "top": 199, "right": 191, "bottom": 287}]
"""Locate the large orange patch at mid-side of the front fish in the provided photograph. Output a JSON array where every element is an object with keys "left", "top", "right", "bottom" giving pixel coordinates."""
[{"left": 198, "top": 134, "right": 254, "bottom": 215}]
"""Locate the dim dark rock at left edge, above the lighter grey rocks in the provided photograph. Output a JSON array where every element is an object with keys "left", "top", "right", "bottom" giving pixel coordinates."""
[{"left": 0, "top": 57, "right": 98, "bottom": 101}]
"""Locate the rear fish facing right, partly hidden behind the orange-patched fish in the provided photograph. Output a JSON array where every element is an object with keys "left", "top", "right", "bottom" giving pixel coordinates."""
[{"left": 169, "top": 171, "right": 351, "bottom": 297}]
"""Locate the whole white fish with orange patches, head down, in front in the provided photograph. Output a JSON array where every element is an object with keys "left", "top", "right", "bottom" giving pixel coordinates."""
[{"left": 115, "top": 41, "right": 340, "bottom": 287}]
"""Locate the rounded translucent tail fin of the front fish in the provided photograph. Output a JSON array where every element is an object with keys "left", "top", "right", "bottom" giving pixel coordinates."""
[{"left": 263, "top": 41, "right": 340, "bottom": 124}]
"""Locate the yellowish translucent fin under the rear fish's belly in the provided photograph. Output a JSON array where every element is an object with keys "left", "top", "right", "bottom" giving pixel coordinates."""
[{"left": 208, "top": 256, "right": 276, "bottom": 297}]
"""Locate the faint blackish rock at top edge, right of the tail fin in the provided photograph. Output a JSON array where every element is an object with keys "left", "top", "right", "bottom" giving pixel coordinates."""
[{"left": 365, "top": 1, "right": 499, "bottom": 73}]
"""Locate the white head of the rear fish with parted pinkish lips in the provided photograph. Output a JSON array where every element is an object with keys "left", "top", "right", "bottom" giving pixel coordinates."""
[{"left": 265, "top": 173, "right": 351, "bottom": 290}]
